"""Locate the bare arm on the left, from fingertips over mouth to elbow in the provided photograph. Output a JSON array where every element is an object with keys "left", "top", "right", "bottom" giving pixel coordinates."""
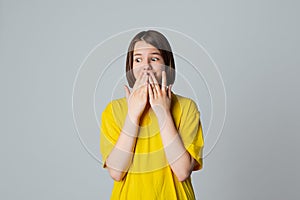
[{"left": 106, "top": 73, "right": 148, "bottom": 181}]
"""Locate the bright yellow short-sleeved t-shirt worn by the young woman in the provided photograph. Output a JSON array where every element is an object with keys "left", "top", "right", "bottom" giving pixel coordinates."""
[{"left": 100, "top": 93, "right": 204, "bottom": 200}]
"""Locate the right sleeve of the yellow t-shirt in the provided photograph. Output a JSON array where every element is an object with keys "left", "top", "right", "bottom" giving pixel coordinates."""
[{"left": 179, "top": 100, "right": 204, "bottom": 170}]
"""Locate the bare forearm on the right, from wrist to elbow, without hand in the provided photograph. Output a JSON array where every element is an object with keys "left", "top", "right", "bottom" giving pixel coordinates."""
[{"left": 158, "top": 113, "right": 194, "bottom": 181}]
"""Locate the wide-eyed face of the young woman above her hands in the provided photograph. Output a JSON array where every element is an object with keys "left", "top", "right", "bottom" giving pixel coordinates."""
[{"left": 133, "top": 41, "right": 165, "bottom": 83}]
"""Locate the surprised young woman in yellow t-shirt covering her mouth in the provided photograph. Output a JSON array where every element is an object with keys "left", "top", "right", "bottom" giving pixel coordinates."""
[{"left": 100, "top": 30, "right": 204, "bottom": 200}]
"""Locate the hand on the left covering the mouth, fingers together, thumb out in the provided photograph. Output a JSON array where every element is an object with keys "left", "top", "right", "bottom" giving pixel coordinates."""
[{"left": 124, "top": 72, "right": 149, "bottom": 125}]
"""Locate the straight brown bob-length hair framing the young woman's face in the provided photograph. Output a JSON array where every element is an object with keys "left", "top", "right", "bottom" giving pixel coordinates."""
[{"left": 126, "top": 30, "right": 175, "bottom": 88}]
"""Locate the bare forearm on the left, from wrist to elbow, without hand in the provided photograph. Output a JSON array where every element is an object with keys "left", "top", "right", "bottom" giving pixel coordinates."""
[{"left": 106, "top": 116, "right": 138, "bottom": 181}]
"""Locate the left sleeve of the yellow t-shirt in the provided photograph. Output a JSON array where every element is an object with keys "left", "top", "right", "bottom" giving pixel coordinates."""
[{"left": 100, "top": 103, "right": 121, "bottom": 167}]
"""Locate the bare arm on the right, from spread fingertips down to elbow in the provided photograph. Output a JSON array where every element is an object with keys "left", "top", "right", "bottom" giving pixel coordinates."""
[{"left": 148, "top": 71, "right": 195, "bottom": 181}]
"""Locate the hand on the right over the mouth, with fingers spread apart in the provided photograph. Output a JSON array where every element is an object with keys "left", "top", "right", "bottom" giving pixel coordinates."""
[{"left": 148, "top": 71, "right": 172, "bottom": 120}]
